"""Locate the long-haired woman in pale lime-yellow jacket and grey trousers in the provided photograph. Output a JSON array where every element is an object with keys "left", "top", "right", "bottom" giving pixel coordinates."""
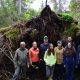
[{"left": 44, "top": 43, "right": 56, "bottom": 80}]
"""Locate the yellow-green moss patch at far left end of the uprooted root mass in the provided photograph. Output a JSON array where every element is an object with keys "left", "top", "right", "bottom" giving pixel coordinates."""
[{"left": 0, "top": 27, "right": 20, "bottom": 41}]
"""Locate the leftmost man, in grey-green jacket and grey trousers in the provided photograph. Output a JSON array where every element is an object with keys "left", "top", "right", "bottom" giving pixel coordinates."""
[{"left": 11, "top": 42, "right": 28, "bottom": 80}]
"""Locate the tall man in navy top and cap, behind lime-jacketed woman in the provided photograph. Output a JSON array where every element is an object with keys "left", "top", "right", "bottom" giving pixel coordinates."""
[{"left": 39, "top": 36, "right": 49, "bottom": 80}]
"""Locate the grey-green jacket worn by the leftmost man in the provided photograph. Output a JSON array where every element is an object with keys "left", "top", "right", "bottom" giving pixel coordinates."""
[{"left": 14, "top": 48, "right": 28, "bottom": 66}]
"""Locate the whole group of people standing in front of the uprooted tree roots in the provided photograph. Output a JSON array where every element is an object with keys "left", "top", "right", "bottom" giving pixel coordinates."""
[{"left": 11, "top": 36, "right": 78, "bottom": 80}]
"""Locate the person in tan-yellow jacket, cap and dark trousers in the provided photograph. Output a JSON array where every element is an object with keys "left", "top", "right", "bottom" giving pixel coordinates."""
[{"left": 54, "top": 40, "right": 64, "bottom": 80}]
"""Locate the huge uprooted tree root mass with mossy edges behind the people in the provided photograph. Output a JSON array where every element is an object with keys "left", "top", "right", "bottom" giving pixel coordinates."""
[{"left": 0, "top": 5, "right": 79, "bottom": 80}]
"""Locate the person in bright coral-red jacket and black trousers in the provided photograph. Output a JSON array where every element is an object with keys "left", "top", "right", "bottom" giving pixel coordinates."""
[{"left": 29, "top": 42, "right": 40, "bottom": 80}]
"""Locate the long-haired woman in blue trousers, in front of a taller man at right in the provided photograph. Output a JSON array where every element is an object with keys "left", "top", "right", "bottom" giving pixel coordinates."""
[{"left": 64, "top": 42, "right": 77, "bottom": 80}]
